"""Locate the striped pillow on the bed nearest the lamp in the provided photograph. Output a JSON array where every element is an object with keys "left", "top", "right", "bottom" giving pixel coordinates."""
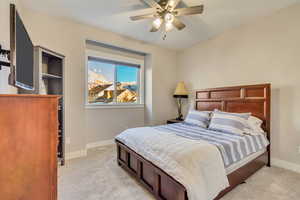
[{"left": 184, "top": 110, "right": 211, "bottom": 128}]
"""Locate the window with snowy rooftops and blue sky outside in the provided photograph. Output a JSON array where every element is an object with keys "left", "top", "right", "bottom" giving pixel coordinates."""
[{"left": 87, "top": 53, "right": 144, "bottom": 106}]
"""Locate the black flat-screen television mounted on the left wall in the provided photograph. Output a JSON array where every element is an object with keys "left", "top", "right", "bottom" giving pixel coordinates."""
[{"left": 9, "top": 4, "right": 34, "bottom": 90}]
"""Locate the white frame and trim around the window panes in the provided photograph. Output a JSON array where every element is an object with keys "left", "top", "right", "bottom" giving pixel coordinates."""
[{"left": 84, "top": 50, "right": 145, "bottom": 109}]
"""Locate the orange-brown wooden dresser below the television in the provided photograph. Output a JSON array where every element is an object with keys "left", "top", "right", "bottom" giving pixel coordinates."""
[{"left": 0, "top": 95, "right": 59, "bottom": 200}]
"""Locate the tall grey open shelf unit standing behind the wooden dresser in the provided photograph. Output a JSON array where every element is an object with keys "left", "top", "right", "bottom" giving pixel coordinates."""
[{"left": 19, "top": 46, "right": 65, "bottom": 165}]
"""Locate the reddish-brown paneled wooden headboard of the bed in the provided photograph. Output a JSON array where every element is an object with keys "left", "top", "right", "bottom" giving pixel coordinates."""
[{"left": 196, "top": 84, "right": 271, "bottom": 140}]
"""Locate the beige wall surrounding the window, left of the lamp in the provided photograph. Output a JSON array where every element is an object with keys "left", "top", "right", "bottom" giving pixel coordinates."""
[{"left": 1, "top": 5, "right": 177, "bottom": 152}]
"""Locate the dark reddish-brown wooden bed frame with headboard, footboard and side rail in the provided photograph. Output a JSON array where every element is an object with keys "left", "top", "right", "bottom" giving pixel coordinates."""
[{"left": 116, "top": 84, "right": 271, "bottom": 200}]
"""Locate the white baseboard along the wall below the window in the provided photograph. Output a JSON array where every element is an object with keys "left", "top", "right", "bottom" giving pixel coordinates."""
[{"left": 66, "top": 139, "right": 115, "bottom": 160}]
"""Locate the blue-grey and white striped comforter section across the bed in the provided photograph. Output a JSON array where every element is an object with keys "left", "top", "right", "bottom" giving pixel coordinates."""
[{"left": 153, "top": 123, "right": 269, "bottom": 167}]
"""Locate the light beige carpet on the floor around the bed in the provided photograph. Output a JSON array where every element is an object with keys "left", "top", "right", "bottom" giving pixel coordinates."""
[{"left": 58, "top": 146, "right": 300, "bottom": 200}]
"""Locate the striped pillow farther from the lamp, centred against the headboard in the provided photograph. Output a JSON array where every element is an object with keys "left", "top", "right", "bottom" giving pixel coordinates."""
[{"left": 209, "top": 110, "right": 251, "bottom": 135}]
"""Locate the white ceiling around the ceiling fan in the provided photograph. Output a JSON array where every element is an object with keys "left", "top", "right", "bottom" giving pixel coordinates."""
[{"left": 22, "top": 0, "right": 300, "bottom": 49}]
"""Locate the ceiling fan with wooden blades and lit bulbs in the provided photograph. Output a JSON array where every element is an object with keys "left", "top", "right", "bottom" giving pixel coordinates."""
[{"left": 130, "top": 0, "right": 204, "bottom": 36}]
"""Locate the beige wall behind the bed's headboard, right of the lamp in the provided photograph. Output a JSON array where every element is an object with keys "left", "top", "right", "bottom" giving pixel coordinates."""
[{"left": 178, "top": 4, "right": 300, "bottom": 164}]
